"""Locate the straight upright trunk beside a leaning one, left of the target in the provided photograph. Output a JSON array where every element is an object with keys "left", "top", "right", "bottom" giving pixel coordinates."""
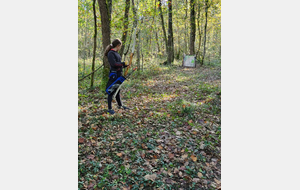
[{"left": 167, "top": 0, "right": 174, "bottom": 64}]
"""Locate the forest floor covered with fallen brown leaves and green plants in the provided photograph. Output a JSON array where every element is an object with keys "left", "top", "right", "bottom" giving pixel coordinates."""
[{"left": 78, "top": 61, "right": 221, "bottom": 190}]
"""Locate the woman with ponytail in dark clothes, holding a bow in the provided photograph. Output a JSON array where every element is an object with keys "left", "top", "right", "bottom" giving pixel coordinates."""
[{"left": 104, "top": 39, "right": 129, "bottom": 114}]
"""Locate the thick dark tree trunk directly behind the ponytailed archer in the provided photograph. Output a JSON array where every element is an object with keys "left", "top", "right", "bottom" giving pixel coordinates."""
[{"left": 98, "top": 0, "right": 110, "bottom": 90}]
